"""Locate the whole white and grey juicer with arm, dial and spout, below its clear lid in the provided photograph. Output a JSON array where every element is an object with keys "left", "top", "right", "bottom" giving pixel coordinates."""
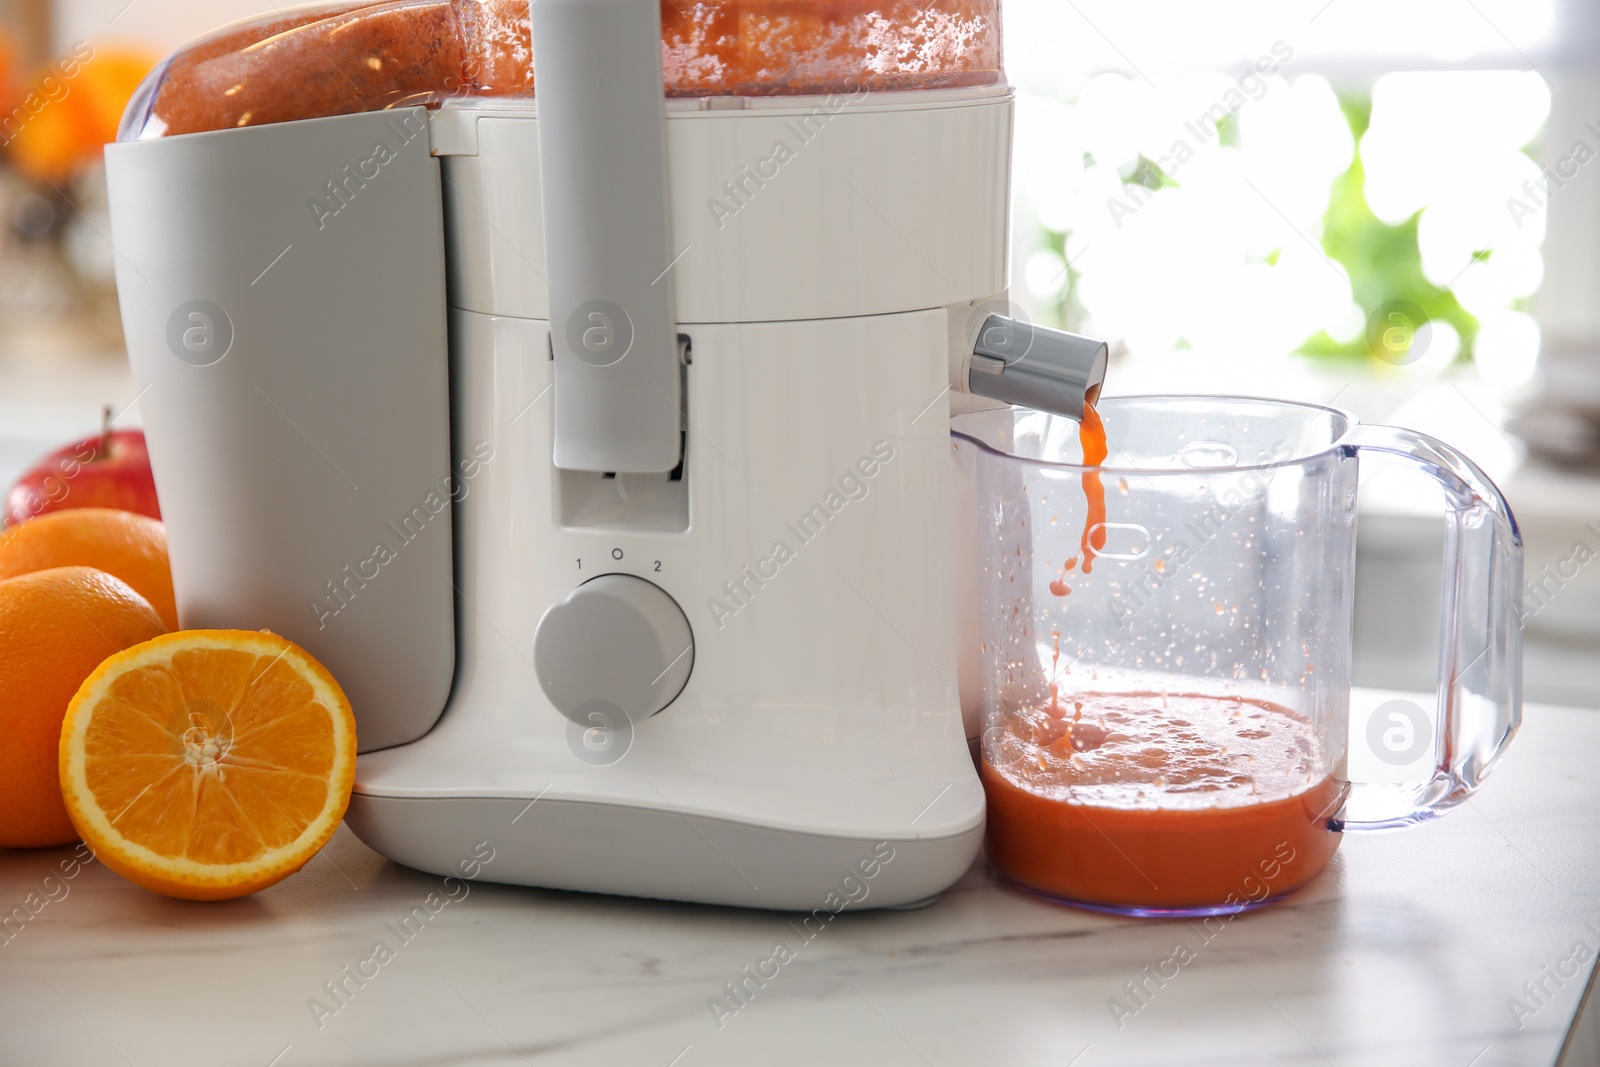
[{"left": 107, "top": 0, "right": 1106, "bottom": 910}]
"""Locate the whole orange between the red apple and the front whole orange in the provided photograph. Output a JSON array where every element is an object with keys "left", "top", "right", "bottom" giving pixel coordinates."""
[{"left": 0, "top": 507, "right": 178, "bottom": 630}]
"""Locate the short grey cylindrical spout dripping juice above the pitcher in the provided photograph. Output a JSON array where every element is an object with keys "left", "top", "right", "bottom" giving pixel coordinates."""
[{"left": 958, "top": 315, "right": 1107, "bottom": 421}]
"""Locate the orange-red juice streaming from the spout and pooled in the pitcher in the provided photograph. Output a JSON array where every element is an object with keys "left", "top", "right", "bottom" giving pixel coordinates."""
[{"left": 981, "top": 387, "right": 1349, "bottom": 912}]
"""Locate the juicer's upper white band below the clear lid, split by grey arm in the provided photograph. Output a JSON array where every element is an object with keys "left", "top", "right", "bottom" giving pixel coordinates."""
[{"left": 434, "top": 86, "right": 1011, "bottom": 321}]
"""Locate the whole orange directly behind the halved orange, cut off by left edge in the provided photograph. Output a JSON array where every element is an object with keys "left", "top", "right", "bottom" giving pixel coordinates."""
[{"left": 0, "top": 566, "right": 163, "bottom": 848}]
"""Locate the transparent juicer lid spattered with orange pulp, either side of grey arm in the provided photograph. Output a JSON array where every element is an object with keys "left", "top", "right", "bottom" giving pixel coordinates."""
[{"left": 118, "top": 0, "right": 1003, "bottom": 141}]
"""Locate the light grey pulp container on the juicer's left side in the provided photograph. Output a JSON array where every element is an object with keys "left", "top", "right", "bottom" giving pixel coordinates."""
[{"left": 106, "top": 107, "right": 457, "bottom": 750}]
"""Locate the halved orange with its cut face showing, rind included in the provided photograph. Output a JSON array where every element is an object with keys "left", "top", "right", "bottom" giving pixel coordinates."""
[{"left": 61, "top": 630, "right": 355, "bottom": 901}]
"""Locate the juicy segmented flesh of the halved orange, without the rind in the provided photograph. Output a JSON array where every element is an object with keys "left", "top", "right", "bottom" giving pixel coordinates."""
[{"left": 85, "top": 648, "right": 334, "bottom": 864}]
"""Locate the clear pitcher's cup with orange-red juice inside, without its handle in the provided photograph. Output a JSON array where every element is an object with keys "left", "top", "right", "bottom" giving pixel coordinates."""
[{"left": 957, "top": 394, "right": 1354, "bottom": 915}]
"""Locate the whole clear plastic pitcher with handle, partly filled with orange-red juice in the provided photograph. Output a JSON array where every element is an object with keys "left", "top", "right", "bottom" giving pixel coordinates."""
[{"left": 954, "top": 397, "right": 1522, "bottom": 915}]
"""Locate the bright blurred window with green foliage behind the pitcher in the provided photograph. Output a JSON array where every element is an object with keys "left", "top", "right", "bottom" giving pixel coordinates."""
[{"left": 1006, "top": 0, "right": 1568, "bottom": 395}]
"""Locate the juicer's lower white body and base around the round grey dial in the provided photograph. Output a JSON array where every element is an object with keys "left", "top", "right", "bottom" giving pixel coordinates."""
[{"left": 349, "top": 303, "right": 984, "bottom": 909}]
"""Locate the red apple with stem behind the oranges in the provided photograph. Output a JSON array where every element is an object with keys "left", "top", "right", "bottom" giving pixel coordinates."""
[{"left": 5, "top": 408, "right": 162, "bottom": 526}]
